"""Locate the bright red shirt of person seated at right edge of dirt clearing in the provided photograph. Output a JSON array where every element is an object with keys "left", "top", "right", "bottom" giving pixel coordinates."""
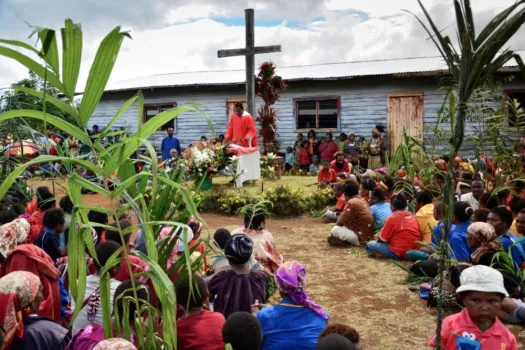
[{"left": 379, "top": 210, "right": 423, "bottom": 259}]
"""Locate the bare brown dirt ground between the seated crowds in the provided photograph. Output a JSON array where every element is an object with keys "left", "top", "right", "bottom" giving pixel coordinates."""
[{"left": 27, "top": 183, "right": 525, "bottom": 350}]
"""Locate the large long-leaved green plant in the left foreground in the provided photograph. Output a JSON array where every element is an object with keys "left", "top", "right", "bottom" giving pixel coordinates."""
[{"left": 0, "top": 20, "right": 213, "bottom": 349}]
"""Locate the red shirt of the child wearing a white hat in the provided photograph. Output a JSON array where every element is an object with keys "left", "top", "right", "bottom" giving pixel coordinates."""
[{"left": 428, "top": 309, "right": 518, "bottom": 350}]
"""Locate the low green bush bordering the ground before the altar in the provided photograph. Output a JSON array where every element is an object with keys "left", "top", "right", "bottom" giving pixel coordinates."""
[{"left": 199, "top": 185, "right": 335, "bottom": 216}]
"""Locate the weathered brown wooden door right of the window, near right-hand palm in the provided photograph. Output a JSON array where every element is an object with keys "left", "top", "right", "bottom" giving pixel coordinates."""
[{"left": 387, "top": 93, "right": 423, "bottom": 153}]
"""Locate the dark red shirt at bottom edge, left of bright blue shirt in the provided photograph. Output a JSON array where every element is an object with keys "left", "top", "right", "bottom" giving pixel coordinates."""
[{"left": 177, "top": 310, "right": 226, "bottom": 350}]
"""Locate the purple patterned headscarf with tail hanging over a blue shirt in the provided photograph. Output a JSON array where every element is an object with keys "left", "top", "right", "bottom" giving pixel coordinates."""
[{"left": 275, "top": 261, "right": 328, "bottom": 320}]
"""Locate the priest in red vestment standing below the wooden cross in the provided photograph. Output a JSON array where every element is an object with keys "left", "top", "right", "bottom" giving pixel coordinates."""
[{"left": 224, "top": 103, "right": 258, "bottom": 147}]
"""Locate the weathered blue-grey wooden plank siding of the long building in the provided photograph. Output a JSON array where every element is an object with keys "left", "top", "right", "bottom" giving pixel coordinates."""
[{"left": 89, "top": 77, "right": 525, "bottom": 151}]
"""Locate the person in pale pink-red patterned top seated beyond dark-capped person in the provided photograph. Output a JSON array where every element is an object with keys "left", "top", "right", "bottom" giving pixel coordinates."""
[{"left": 232, "top": 207, "right": 284, "bottom": 275}]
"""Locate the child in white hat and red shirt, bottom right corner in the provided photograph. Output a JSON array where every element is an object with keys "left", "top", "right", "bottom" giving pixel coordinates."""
[{"left": 429, "top": 265, "right": 518, "bottom": 350}]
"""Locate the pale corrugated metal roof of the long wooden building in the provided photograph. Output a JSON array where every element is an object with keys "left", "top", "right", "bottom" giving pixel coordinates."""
[{"left": 105, "top": 51, "right": 525, "bottom": 91}]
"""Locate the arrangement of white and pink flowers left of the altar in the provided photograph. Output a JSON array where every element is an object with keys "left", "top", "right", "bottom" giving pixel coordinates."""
[{"left": 182, "top": 141, "right": 227, "bottom": 180}]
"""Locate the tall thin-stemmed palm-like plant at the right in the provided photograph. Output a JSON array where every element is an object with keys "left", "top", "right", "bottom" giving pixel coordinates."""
[{"left": 408, "top": 0, "right": 525, "bottom": 350}]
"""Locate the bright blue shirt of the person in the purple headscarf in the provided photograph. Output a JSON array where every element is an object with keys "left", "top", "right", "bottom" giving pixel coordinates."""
[{"left": 257, "top": 298, "right": 327, "bottom": 350}]
